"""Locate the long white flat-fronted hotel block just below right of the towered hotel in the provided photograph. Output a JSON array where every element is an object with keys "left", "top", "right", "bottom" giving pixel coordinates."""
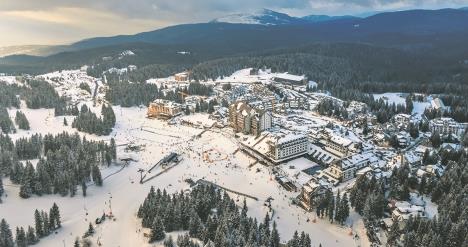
[{"left": 267, "top": 133, "right": 309, "bottom": 162}]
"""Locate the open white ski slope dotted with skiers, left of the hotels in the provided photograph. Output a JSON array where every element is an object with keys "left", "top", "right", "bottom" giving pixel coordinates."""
[{"left": 0, "top": 107, "right": 369, "bottom": 246}]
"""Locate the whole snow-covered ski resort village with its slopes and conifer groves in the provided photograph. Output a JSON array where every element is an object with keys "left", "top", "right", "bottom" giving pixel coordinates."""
[{"left": 0, "top": 64, "right": 468, "bottom": 247}]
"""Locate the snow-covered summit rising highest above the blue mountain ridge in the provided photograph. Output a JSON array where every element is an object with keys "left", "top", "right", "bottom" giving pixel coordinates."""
[{"left": 211, "top": 9, "right": 304, "bottom": 25}]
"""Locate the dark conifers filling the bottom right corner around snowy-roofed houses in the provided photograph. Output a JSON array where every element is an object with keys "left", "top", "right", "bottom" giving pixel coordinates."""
[{"left": 350, "top": 148, "right": 468, "bottom": 247}]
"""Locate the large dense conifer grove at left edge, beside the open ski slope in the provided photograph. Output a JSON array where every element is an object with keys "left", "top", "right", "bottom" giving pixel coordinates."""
[{"left": 0, "top": 132, "right": 116, "bottom": 198}]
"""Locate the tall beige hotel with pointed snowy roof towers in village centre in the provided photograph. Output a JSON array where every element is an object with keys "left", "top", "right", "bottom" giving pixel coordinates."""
[{"left": 229, "top": 101, "right": 273, "bottom": 135}]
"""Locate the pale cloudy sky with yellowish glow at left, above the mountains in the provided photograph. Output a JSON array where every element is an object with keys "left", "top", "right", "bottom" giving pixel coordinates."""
[{"left": 0, "top": 0, "right": 468, "bottom": 46}]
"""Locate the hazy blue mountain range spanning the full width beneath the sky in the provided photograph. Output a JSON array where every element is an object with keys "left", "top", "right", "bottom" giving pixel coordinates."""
[{"left": 0, "top": 8, "right": 468, "bottom": 75}]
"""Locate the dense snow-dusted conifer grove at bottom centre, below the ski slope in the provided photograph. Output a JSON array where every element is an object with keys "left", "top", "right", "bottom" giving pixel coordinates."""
[{"left": 137, "top": 185, "right": 311, "bottom": 247}]
